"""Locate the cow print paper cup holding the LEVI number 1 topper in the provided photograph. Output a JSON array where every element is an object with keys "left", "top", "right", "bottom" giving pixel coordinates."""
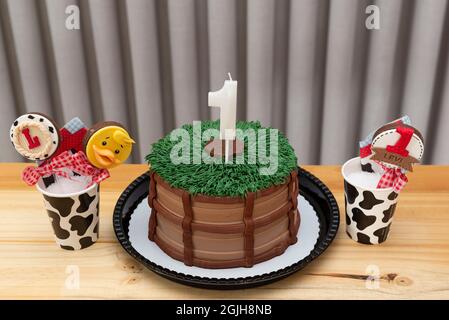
[{"left": 341, "top": 157, "right": 398, "bottom": 244}]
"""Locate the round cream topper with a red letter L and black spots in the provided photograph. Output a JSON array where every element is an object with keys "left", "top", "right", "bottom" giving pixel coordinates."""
[{"left": 10, "top": 112, "right": 60, "bottom": 161}]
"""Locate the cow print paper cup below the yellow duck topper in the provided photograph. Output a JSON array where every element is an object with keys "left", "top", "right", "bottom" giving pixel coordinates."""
[{"left": 36, "top": 179, "right": 100, "bottom": 250}]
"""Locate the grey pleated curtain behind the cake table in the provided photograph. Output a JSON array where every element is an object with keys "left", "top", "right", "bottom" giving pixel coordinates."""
[{"left": 0, "top": 0, "right": 449, "bottom": 164}]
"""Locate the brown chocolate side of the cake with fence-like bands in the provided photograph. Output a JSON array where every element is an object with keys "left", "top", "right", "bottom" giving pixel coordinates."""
[{"left": 148, "top": 171, "right": 300, "bottom": 268}]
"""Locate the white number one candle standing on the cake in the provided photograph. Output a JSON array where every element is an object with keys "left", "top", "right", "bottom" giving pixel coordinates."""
[{"left": 208, "top": 73, "right": 237, "bottom": 163}]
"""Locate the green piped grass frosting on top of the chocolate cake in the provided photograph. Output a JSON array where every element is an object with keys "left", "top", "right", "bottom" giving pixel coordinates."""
[{"left": 145, "top": 120, "right": 297, "bottom": 197}]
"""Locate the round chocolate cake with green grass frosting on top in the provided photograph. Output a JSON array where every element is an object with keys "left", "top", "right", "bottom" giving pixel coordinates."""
[{"left": 146, "top": 121, "right": 300, "bottom": 268}]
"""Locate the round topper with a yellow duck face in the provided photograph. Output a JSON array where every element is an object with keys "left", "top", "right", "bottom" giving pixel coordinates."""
[{"left": 84, "top": 121, "right": 135, "bottom": 169}]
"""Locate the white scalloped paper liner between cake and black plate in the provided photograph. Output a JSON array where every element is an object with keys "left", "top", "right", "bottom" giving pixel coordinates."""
[{"left": 128, "top": 195, "right": 320, "bottom": 279}]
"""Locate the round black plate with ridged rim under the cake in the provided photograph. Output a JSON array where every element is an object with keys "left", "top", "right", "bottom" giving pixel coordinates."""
[{"left": 113, "top": 168, "right": 340, "bottom": 289}]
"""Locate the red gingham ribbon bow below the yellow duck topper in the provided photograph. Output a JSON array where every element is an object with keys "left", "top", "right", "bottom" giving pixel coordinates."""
[{"left": 22, "top": 151, "right": 109, "bottom": 187}]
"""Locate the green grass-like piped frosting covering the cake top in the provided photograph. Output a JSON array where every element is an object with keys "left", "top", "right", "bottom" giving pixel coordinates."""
[{"left": 145, "top": 120, "right": 297, "bottom": 197}]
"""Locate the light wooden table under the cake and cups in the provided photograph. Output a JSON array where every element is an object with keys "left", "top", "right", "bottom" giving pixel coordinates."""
[{"left": 0, "top": 164, "right": 449, "bottom": 299}]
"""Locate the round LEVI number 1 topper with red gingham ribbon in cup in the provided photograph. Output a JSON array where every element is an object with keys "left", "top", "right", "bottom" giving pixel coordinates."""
[{"left": 359, "top": 116, "right": 424, "bottom": 193}]
